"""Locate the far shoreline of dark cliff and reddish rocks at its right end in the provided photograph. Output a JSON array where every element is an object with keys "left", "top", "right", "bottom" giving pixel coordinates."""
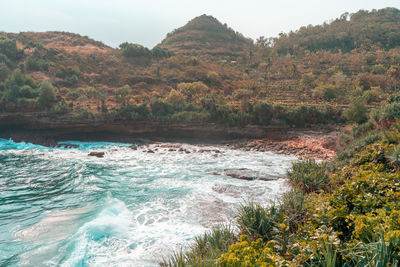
[{"left": 0, "top": 113, "right": 340, "bottom": 160}]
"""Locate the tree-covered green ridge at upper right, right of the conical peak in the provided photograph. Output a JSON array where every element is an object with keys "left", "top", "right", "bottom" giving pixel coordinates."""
[{"left": 274, "top": 8, "right": 400, "bottom": 54}]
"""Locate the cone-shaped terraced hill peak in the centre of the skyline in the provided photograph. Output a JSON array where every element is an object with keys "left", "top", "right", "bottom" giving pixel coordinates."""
[{"left": 159, "top": 15, "right": 253, "bottom": 55}]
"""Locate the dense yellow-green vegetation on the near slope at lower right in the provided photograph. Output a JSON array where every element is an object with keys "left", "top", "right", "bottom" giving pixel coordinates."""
[{"left": 161, "top": 96, "right": 400, "bottom": 267}]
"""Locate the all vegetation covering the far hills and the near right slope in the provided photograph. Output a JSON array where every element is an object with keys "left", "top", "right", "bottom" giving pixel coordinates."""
[{"left": 0, "top": 5, "right": 400, "bottom": 266}]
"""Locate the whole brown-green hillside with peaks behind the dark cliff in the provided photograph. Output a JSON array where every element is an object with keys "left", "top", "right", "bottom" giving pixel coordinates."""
[{"left": 0, "top": 8, "right": 400, "bottom": 126}]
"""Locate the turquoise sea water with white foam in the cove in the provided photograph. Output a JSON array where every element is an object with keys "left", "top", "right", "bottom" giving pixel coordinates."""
[{"left": 0, "top": 139, "right": 295, "bottom": 266}]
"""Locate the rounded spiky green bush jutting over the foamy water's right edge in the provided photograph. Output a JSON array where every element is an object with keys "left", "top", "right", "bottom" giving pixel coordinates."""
[{"left": 287, "top": 159, "right": 329, "bottom": 193}]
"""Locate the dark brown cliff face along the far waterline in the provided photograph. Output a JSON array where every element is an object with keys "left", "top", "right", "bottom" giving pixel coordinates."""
[{"left": 0, "top": 114, "right": 286, "bottom": 145}]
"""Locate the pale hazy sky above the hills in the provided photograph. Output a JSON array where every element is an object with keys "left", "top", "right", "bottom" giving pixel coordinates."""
[{"left": 0, "top": 0, "right": 400, "bottom": 48}]
